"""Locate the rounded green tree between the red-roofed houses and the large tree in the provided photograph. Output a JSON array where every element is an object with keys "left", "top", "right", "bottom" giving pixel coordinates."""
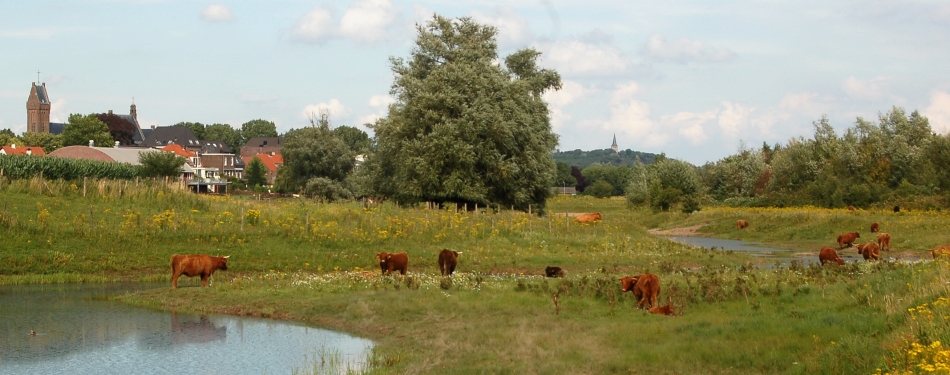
[{"left": 275, "top": 113, "right": 356, "bottom": 192}]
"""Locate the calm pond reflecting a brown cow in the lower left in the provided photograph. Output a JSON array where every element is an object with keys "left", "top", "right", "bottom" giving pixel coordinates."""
[{"left": 0, "top": 283, "right": 373, "bottom": 374}]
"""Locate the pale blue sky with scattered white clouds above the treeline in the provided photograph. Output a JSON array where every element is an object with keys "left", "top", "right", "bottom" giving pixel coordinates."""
[{"left": 0, "top": 0, "right": 950, "bottom": 165}]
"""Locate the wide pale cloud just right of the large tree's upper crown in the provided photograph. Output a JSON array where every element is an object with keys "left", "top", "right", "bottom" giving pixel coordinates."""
[{"left": 540, "top": 40, "right": 628, "bottom": 76}]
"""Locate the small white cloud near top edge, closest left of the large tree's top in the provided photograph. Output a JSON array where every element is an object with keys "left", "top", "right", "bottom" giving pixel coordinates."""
[{"left": 340, "top": 0, "right": 400, "bottom": 43}]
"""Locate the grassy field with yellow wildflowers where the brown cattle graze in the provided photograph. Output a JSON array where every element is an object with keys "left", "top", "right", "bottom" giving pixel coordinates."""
[{"left": 0, "top": 180, "right": 950, "bottom": 374}]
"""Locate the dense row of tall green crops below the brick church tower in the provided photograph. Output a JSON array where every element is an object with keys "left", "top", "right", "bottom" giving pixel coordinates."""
[{"left": 0, "top": 155, "right": 139, "bottom": 180}]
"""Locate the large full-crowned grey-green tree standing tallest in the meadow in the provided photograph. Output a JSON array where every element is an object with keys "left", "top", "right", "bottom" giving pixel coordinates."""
[{"left": 365, "top": 15, "right": 561, "bottom": 210}]
